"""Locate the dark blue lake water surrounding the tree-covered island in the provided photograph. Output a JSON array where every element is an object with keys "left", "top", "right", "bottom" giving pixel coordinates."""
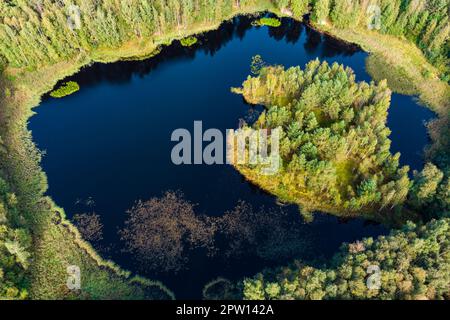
[{"left": 29, "top": 18, "right": 433, "bottom": 298}]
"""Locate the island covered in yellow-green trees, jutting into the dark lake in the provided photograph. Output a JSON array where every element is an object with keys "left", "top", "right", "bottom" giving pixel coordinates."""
[{"left": 234, "top": 58, "right": 448, "bottom": 218}]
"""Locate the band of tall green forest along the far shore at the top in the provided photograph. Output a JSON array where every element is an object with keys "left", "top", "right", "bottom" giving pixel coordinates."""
[{"left": 0, "top": 0, "right": 450, "bottom": 81}]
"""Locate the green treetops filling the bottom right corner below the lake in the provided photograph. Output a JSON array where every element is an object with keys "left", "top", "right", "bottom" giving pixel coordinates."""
[{"left": 241, "top": 218, "right": 450, "bottom": 300}]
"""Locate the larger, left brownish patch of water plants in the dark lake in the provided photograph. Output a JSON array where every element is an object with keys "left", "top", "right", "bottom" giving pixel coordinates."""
[{"left": 120, "top": 192, "right": 214, "bottom": 272}]
